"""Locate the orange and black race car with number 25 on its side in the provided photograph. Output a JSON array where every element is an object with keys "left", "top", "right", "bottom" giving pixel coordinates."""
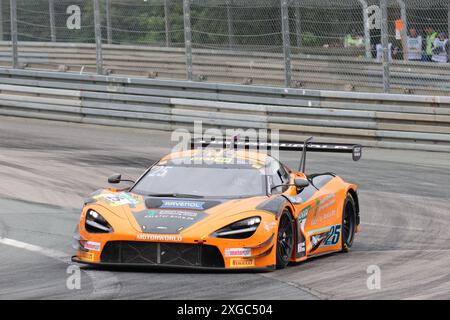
[{"left": 72, "top": 139, "right": 361, "bottom": 270}]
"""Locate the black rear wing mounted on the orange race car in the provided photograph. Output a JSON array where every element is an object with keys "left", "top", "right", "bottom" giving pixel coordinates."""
[{"left": 191, "top": 137, "right": 362, "bottom": 172}]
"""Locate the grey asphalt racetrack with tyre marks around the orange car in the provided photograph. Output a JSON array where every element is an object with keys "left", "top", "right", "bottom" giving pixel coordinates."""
[{"left": 0, "top": 117, "right": 450, "bottom": 299}]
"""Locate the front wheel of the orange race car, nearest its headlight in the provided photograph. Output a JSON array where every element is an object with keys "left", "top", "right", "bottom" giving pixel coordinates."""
[{"left": 277, "top": 209, "right": 294, "bottom": 269}]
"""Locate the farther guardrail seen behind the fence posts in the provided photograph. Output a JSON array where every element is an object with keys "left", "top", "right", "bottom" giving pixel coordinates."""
[{"left": 0, "top": 41, "right": 450, "bottom": 95}]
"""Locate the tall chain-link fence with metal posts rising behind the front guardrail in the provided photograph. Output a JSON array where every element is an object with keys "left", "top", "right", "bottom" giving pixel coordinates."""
[{"left": 0, "top": 0, "right": 450, "bottom": 94}]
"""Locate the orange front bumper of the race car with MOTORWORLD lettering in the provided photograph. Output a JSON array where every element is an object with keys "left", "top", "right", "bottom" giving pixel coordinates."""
[{"left": 73, "top": 204, "right": 276, "bottom": 270}]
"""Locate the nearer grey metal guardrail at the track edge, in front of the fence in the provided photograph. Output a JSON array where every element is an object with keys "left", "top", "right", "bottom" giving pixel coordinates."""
[{"left": 0, "top": 68, "right": 450, "bottom": 152}]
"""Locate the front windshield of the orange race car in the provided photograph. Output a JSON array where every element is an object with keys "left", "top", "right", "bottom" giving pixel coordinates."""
[{"left": 133, "top": 165, "right": 266, "bottom": 198}]
